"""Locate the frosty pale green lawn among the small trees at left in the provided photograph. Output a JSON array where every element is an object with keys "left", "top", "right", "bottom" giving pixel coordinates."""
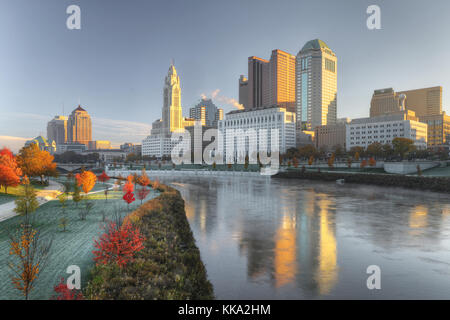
[{"left": 0, "top": 184, "right": 158, "bottom": 300}]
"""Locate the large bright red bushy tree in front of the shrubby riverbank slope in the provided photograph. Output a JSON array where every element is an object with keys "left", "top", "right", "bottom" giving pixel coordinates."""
[{"left": 92, "top": 222, "right": 145, "bottom": 268}]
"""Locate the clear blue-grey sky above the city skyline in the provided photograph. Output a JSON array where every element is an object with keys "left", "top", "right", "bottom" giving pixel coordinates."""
[{"left": 0, "top": 0, "right": 450, "bottom": 150}]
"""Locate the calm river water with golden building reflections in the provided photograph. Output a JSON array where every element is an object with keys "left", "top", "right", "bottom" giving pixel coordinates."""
[{"left": 157, "top": 177, "right": 450, "bottom": 299}]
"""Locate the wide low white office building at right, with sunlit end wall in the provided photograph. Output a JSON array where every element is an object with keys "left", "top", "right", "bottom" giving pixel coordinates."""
[{"left": 345, "top": 111, "right": 428, "bottom": 150}]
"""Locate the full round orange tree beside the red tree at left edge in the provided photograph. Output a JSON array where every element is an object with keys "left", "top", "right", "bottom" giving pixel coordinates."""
[{"left": 17, "top": 143, "right": 58, "bottom": 184}]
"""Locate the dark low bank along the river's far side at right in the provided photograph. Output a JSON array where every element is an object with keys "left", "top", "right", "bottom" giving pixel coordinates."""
[{"left": 273, "top": 171, "right": 450, "bottom": 193}]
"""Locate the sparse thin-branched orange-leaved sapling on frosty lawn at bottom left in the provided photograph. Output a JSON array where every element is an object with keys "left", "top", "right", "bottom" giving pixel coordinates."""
[{"left": 8, "top": 216, "right": 52, "bottom": 300}]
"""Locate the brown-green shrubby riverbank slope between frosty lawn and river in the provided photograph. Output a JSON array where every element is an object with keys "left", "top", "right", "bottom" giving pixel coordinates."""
[{"left": 85, "top": 185, "right": 214, "bottom": 300}]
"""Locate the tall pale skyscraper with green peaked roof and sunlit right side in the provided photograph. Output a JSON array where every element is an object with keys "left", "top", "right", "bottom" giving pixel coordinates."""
[{"left": 296, "top": 39, "right": 337, "bottom": 130}]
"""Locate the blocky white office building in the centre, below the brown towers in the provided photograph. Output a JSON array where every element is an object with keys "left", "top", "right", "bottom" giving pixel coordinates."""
[{"left": 218, "top": 106, "right": 296, "bottom": 161}]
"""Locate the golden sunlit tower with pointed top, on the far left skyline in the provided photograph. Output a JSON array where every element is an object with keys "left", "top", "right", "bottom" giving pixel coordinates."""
[{"left": 67, "top": 105, "right": 92, "bottom": 147}]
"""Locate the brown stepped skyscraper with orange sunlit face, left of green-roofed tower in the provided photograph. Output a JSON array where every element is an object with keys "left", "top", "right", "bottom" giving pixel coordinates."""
[{"left": 244, "top": 49, "right": 295, "bottom": 112}]
